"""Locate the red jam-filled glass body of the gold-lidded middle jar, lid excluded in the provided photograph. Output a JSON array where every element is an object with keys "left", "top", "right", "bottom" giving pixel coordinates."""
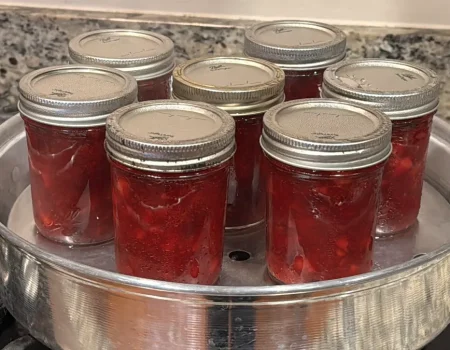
[{"left": 226, "top": 114, "right": 265, "bottom": 230}]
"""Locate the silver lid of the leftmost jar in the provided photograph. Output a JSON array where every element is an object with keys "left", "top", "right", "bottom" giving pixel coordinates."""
[{"left": 18, "top": 65, "right": 137, "bottom": 128}]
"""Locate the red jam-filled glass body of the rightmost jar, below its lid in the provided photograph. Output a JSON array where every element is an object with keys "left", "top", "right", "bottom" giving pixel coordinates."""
[{"left": 377, "top": 113, "right": 434, "bottom": 236}]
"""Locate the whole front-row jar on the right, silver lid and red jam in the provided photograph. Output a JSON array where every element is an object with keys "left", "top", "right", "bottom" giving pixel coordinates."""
[{"left": 261, "top": 99, "right": 391, "bottom": 284}]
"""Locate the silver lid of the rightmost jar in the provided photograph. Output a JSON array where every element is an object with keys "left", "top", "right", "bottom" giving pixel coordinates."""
[{"left": 322, "top": 59, "right": 439, "bottom": 120}]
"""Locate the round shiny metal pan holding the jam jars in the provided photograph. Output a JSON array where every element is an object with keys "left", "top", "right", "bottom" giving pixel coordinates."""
[{"left": 0, "top": 118, "right": 450, "bottom": 350}]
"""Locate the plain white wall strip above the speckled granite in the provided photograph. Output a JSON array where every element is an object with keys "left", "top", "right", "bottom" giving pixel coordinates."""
[{"left": 0, "top": 0, "right": 450, "bottom": 28}]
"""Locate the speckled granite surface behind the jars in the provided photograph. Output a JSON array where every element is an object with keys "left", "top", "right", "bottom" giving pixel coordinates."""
[{"left": 0, "top": 7, "right": 450, "bottom": 120}]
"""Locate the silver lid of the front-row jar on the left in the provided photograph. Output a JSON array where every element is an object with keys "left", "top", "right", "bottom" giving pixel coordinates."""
[{"left": 106, "top": 100, "right": 236, "bottom": 172}]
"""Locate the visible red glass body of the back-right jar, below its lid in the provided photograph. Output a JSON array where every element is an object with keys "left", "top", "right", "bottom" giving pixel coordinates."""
[{"left": 284, "top": 69, "right": 325, "bottom": 101}]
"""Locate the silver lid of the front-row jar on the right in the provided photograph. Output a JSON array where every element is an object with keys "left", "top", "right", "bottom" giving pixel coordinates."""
[{"left": 261, "top": 99, "right": 392, "bottom": 170}]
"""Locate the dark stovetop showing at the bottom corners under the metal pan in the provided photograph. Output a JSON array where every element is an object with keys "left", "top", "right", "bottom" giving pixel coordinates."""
[{"left": 0, "top": 303, "right": 450, "bottom": 350}]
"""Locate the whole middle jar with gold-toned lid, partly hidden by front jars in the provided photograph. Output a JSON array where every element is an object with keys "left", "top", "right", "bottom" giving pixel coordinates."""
[{"left": 173, "top": 57, "right": 284, "bottom": 232}]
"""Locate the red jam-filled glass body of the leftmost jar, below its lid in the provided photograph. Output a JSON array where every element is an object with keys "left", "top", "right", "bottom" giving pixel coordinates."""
[{"left": 22, "top": 116, "right": 113, "bottom": 244}]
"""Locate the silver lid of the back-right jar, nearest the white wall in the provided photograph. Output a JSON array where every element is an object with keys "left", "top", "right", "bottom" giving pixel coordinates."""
[{"left": 244, "top": 20, "right": 347, "bottom": 70}]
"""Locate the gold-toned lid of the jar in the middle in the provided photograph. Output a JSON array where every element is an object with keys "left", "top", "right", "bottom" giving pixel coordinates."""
[{"left": 173, "top": 57, "right": 284, "bottom": 116}]
